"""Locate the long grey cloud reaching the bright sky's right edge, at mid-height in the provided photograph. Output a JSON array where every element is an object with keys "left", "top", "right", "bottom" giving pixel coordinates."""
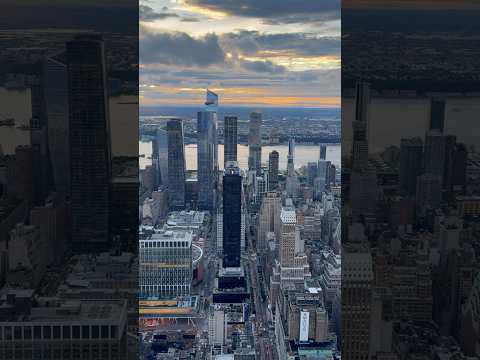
[{"left": 221, "top": 31, "right": 340, "bottom": 56}]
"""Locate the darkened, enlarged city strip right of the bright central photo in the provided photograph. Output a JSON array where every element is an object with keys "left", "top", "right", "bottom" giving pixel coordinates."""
[{"left": 341, "top": 0, "right": 480, "bottom": 360}]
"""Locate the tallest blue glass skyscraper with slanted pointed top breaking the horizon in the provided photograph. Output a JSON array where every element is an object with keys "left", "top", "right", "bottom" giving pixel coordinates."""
[{"left": 197, "top": 90, "right": 218, "bottom": 210}]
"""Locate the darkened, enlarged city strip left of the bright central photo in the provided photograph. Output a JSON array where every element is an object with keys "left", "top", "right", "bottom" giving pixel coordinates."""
[{"left": 0, "top": 0, "right": 138, "bottom": 359}]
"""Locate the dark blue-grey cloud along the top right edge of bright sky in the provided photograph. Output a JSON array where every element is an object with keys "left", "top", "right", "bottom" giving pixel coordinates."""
[{"left": 186, "top": 0, "right": 340, "bottom": 23}]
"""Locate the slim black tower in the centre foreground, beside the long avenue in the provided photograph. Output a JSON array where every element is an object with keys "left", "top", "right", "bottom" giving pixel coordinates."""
[{"left": 223, "top": 162, "right": 242, "bottom": 268}]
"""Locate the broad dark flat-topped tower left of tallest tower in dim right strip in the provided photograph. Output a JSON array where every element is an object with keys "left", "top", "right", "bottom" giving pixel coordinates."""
[{"left": 399, "top": 137, "right": 423, "bottom": 196}]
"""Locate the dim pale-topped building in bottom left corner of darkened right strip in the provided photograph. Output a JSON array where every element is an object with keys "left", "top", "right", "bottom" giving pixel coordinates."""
[{"left": 341, "top": 249, "right": 373, "bottom": 360}]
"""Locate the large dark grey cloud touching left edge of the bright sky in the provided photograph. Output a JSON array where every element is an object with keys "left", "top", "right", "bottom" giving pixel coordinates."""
[{"left": 140, "top": 28, "right": 225, "bottom": 66}]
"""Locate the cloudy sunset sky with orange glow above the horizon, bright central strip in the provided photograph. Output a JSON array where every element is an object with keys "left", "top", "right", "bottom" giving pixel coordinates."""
[{"left": 140, "top": 0, "right": 340, "bottom": 107}]
